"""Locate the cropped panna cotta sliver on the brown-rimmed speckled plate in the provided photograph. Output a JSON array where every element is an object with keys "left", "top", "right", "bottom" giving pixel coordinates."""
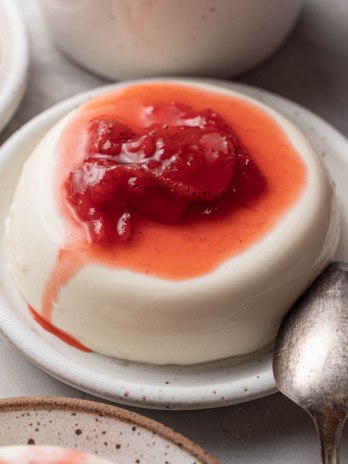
[{"left": 0, "top": 445, "right": 112, "bottom": 464}]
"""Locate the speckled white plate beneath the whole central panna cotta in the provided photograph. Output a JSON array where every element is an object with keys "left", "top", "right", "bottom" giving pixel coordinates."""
[{"left": 0, "top": 80, "right": 348, "bottom": 409}]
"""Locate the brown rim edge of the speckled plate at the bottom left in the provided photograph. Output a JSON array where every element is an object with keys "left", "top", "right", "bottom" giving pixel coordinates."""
[{"left": 0, "top": 396, "right": 218, "bottom": 464}]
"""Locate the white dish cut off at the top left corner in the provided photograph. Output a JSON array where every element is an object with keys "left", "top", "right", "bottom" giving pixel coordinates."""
[{"left": 0, "top": 0, "right": 29, "bottom": 132}]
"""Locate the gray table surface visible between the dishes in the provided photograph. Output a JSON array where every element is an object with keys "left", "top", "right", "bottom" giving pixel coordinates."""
[{"left": 0, "top": 0, "right": 348, "bottom": 464}]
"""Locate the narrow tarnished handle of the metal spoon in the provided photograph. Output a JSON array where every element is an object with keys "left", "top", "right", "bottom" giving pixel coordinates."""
[{"left": 311, "top": 411, "right": 346, "bottom": 464}]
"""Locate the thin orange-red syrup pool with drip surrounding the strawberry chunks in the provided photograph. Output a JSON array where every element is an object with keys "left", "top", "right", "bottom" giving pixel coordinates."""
[{"left": 34, "top": 83, "right": 307, "bottom": 320}]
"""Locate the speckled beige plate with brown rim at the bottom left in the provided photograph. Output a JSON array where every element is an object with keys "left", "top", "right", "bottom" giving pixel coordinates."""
[{"left": 0, "top": 397, "right": 218, "bottom": 464}]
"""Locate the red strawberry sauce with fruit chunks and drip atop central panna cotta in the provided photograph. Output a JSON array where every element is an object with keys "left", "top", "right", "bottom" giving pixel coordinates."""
[{"left": 40, "top": 83, "right": 307, "bottom": 330}]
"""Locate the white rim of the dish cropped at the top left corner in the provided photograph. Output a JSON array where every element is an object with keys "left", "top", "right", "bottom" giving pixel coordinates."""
[{"left": 0, "top": 0, "right": 30, "bottom": 133}]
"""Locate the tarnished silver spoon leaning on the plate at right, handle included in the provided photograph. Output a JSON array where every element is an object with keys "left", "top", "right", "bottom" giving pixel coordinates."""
[{"left": 273, "top": 262, "right": 348, "bottom": 464}]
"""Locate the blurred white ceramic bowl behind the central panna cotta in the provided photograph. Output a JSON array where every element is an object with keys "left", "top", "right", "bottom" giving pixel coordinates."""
[{"left": 36, "top": 0, "right": 303, "bottom": 79}]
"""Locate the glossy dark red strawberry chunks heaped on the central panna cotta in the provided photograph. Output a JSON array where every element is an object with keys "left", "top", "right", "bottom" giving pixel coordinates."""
[{"left": 65, "top": 102, "right": 266, "bottom": 245}]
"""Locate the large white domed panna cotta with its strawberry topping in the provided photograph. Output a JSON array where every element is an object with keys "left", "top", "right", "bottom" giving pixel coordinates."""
[{"left": 7, "top": 81, "right": 339, "bottom": 364}]
